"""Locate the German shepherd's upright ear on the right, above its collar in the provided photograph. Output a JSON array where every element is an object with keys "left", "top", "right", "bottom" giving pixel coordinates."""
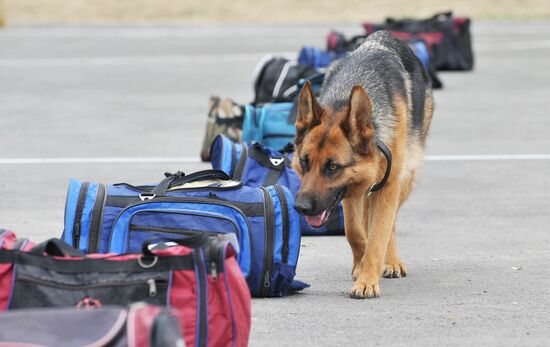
[{"left": 340, "top": 86, "right": 374, "bottom": 155}]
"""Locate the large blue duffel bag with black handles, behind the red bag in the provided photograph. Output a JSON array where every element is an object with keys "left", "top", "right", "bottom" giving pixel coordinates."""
[{"left": 62, "top": 170, "right": 307, "bottom": 297}]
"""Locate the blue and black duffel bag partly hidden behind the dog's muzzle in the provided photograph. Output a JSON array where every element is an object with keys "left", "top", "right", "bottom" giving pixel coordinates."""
[{"left": 211, "top": 135, "right": 344, "bottom": 235}]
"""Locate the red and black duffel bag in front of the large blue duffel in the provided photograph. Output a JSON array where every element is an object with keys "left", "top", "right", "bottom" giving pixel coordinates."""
[{"left": 0, "top": 230, "right": 250, "bottom": 346}]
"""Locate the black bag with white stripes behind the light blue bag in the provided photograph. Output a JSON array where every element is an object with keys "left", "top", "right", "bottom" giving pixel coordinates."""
[{"left": 253, "top": 56, "right": 319, "bottom": 105}]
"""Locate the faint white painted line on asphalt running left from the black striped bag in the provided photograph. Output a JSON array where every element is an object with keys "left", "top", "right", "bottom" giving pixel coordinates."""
[{"left": 0, "top": 52, "right": 298, "bottom": 68}]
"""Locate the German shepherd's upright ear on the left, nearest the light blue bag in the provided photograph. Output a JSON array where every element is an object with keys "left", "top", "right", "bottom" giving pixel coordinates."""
[{"left": 295, "top": 81, "right": 323, "bottom": 145}]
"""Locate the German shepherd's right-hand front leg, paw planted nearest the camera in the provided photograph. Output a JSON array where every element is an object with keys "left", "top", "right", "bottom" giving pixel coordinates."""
[{"left": 351, "top": 184, "right": 399, "bottom": 299}]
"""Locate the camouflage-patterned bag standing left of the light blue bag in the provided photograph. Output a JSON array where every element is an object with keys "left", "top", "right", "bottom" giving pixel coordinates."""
[{"left": 201, "top": 96, "right": 244, "bottom": 161}]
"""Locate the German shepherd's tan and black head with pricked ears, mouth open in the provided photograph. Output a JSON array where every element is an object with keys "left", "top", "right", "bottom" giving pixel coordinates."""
[{"left": 292, "top": 83, "right": 384, "bottom": 227}]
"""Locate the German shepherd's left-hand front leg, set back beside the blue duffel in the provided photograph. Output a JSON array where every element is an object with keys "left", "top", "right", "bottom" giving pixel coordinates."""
[{"left": 342, "top": 196, "right": 368, "bottom": 281}]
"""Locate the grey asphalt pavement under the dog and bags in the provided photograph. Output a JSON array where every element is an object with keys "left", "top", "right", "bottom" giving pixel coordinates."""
[{"left": 0, "top": 21, "right": 550, "bottom": 346}]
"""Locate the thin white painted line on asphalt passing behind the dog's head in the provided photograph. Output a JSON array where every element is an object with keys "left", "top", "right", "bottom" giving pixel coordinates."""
[{"left": 0, "top": 154, "right": 550, "bottom": 165}]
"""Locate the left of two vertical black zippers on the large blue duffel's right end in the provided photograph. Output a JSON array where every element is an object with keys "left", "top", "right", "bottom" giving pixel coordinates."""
[{"left": 260, "top": 187, "right": 275, "bottom": 297}]
